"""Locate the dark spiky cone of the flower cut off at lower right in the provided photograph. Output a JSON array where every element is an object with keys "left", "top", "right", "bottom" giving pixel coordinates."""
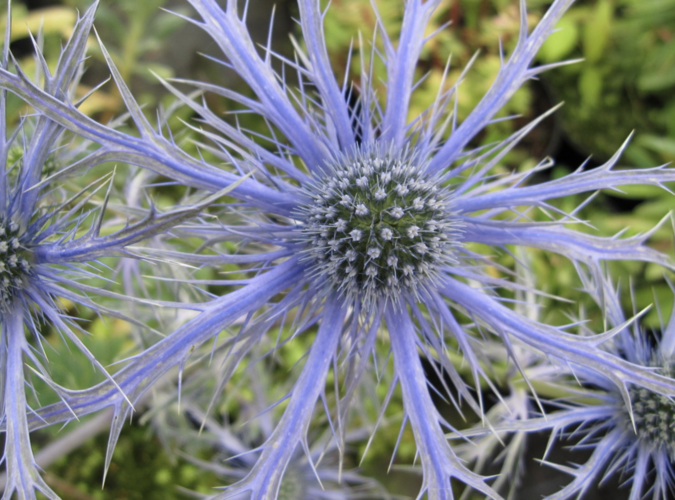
[{"left": 628, "top": 387, "right": 675, "bottom": 460}]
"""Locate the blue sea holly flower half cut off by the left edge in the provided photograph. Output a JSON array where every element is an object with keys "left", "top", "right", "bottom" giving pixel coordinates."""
[{"left": 0, "top": 8, "right": 242, "bottom": 500}]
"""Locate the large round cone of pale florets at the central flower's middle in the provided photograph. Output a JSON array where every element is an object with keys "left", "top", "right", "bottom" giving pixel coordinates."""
[{"left": 301, "top": 148, "right": 458, "bottom": 302}]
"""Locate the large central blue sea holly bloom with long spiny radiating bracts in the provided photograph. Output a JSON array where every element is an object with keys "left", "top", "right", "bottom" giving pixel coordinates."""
[{"left": 6, "top": 0, "right": 675, "bottom": 500}]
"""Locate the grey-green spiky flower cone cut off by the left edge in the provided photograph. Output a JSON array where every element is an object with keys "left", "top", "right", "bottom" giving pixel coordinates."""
[{"left": 0, "top": 218, "right": 30, "bottom": 309}]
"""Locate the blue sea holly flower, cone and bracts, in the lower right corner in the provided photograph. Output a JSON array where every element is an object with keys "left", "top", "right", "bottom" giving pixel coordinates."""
[{"left": 457, "top": 275, "right": 675, "bottom": 500}]
